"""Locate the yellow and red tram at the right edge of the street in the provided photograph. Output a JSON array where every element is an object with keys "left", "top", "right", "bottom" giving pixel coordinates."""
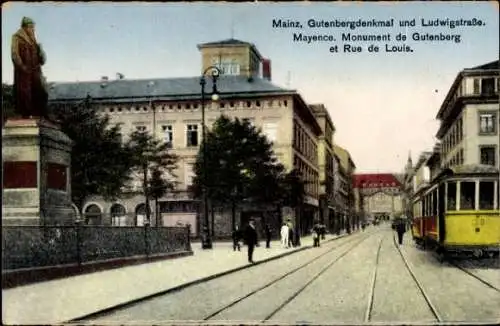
[{"left": 412, "top": 165, "right": 500, "bottom": 257}]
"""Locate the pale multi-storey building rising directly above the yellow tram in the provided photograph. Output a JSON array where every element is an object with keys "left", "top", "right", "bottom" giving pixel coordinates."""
[{"left": 436, "top": 60, "right": 500, "bottom": 168}]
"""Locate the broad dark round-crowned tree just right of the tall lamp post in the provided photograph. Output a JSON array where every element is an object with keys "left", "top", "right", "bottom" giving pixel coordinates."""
[{"left": 192, "top": 115, "right": 284, "bottom": 232}]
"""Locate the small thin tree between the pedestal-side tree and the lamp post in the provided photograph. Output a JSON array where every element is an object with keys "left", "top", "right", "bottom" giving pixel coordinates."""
[{"left": 126, "top": 130, "right": 178, "bottom": 226}]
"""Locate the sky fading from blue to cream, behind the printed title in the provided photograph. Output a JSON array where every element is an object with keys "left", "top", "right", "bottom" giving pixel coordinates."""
[{"left": 2, "top": 2, "right": 499, "bottom": 173}]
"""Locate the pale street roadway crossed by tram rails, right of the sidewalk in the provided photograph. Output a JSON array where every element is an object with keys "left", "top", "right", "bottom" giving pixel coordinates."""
[{"left": 80, "top": 224, "right": 500, "bottom": 325}]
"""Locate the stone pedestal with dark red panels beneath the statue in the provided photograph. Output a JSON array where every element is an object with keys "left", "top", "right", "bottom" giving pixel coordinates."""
[{"left": 2, "top": 119, "right": 75, "bottom": 225}]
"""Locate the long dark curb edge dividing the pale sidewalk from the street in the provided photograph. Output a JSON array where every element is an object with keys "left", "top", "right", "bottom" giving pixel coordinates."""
[{"left": 68, "top": 233, "right": 352, "bottom": 323}]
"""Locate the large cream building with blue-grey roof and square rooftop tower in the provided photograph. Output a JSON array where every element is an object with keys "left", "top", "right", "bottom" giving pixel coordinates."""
[{"left": 50, "top": 39, "right": 322, "bottom": 235}]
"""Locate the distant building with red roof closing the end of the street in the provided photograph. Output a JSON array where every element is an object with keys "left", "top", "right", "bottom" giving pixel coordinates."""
[{"left": 353, "top": 173, "right": 404, "bottom": 220}]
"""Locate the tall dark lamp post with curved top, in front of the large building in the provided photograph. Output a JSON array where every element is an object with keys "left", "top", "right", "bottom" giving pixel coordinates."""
[{"left": 200, "top": 66, "right": 220, "bottom": 249}]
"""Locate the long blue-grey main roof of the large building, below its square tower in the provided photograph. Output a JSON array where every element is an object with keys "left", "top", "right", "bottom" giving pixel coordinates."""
[{"left": 49, "top": 75, "right": 295, "bottom": 101}]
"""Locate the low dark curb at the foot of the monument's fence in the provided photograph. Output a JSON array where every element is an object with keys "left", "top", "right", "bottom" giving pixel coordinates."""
[{"left": 2, "top": 250, "right": 193, "bottom": 290}]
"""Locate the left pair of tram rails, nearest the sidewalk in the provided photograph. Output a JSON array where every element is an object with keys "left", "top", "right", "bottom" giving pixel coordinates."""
[{"left": 203, "top": 232, "right": 376, "bottom": 323}]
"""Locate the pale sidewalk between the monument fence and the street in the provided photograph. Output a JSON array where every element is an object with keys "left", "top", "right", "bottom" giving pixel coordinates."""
[{"left": 2, "top": 234, "right": 344, "bottom": 325}]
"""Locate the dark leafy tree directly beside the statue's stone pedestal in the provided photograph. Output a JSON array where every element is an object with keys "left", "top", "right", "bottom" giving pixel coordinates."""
[{"left": 49, "top": 97, "right": 132, "bottom": 211}]
